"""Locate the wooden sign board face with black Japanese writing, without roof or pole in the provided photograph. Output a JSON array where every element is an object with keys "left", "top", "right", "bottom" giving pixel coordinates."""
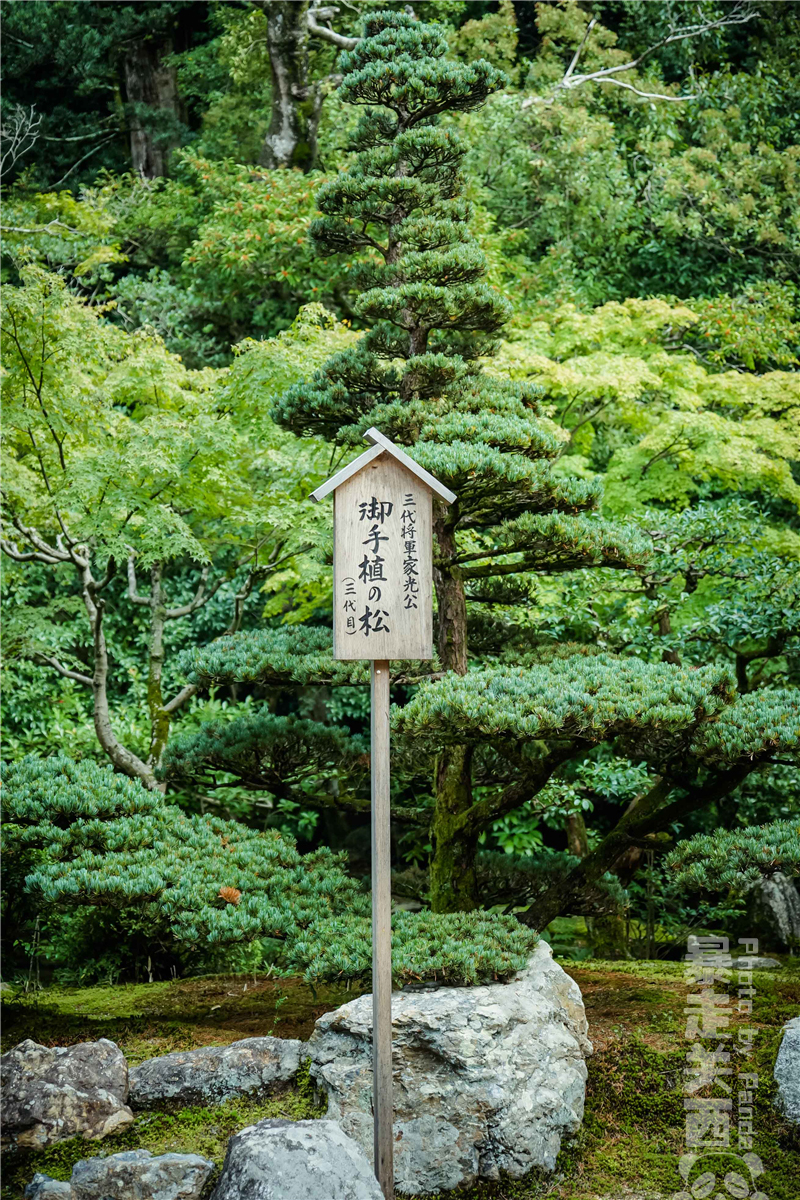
[{"left": 333, "top": 454, "right": 433, "bottom": 659}]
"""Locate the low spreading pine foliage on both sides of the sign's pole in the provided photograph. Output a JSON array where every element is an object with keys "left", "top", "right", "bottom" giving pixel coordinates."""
[{"left": 2, "top": 758, "right": 536, "bottom": 984}]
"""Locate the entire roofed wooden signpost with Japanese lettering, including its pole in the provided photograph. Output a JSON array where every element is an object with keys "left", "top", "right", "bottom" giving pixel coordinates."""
[{"left": 312, "top": 428, "right": 456, "bottom": 1200}]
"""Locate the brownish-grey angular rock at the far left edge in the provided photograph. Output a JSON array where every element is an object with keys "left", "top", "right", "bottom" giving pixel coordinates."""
[{"left": 0, "top": 1038, "right": 133, "bottom": 1147}]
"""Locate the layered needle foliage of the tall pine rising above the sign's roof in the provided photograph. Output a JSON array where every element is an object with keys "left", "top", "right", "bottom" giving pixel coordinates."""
[{"left": 275, "top": 3, "right": 620, "bottom": 549}]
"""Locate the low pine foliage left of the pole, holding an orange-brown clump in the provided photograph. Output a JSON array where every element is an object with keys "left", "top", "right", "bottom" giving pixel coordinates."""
[{"left": 2, "top": 755, "right": 368, "bottom": 947}]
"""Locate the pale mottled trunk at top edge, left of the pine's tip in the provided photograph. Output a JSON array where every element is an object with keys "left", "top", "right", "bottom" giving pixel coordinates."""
[{"left": 259, "top": 0, "right": 323, "bottom": 172}]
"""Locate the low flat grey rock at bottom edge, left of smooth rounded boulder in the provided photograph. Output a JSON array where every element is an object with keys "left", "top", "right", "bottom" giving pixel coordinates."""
[{"left": 71, "top": 1150, "right": 213, "bottom": 1200}]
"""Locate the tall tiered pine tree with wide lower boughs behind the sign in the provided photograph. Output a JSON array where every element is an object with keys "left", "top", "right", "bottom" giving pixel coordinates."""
[{"left": 183, "top": 13, "right": 800, "bottom": 929}]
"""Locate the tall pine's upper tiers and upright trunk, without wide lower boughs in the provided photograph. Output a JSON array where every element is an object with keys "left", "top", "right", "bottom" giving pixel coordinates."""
[{"left": 275, "top": 12, "right": 637, "bottom": 911}]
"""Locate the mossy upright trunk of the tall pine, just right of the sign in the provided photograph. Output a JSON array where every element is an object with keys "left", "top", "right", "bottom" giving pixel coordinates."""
[{"left": 431, "top": 512, "right": 479, "bottom": 912}]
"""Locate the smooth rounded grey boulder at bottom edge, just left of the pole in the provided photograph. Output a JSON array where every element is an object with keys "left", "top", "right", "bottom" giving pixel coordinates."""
[{"left": 211, "top": 1118, "right": 383, "bottom": 1200}]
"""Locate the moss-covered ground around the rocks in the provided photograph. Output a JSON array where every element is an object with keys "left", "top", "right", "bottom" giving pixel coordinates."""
[{"left": 2, "top": 960, "right": 800, "bottom": 1200}]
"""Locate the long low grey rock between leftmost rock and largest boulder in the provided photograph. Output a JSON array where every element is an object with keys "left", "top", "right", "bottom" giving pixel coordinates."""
[{"left": 131, "top": 1038, "right": 302, "bottom": 1109}]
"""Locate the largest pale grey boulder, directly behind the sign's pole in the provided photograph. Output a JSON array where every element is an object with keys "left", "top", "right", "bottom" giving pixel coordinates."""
[{"left": 308, "top": 942, "right": 591, "bottom": 1193}]
